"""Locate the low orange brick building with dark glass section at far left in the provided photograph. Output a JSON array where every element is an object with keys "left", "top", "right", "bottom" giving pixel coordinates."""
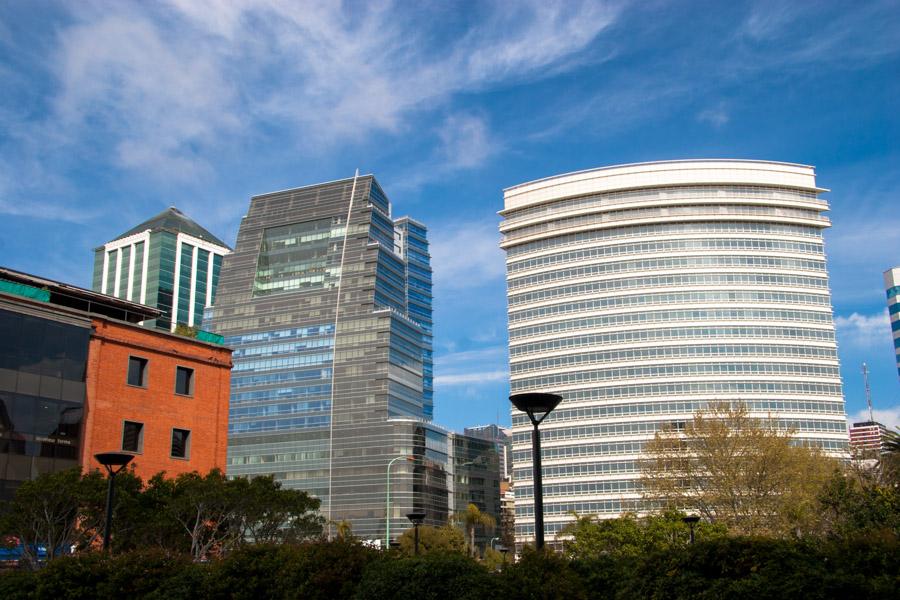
[{"left": 0, "top": 268, "right": 231, "bottom": 499}]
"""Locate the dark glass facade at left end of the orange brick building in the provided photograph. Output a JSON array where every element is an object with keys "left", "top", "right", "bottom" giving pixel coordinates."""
[{"left": 0, "top": 306, "right": 91, "bottom": 501}]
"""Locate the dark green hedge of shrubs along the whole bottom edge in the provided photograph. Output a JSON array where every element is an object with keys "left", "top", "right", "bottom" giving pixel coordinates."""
[{"left": 0, "top": 536, "right": 900, "bottom": 600}]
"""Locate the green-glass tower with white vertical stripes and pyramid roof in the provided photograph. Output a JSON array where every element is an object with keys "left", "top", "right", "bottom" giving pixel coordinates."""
[{"left": 92, "top": 206, "right": 231, "bottom": 331}]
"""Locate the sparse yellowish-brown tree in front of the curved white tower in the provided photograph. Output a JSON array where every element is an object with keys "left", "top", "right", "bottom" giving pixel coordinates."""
[{"left": 641, "top": 403, "right": 835, "bottom": 536}]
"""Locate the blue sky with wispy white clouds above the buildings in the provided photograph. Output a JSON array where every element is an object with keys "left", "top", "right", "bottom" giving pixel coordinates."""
[{"left": 0, "top": 0, "right": 900, "bottom": 429}]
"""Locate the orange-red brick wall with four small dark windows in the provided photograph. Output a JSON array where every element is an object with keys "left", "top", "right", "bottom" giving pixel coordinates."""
[{"left": 81, "top": 317, "right": 231, "bottom": 481}]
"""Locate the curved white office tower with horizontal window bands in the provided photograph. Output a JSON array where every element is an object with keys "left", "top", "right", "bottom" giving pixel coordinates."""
[{"left": 500, "top": 160, "right": 848, "bottom": 542}]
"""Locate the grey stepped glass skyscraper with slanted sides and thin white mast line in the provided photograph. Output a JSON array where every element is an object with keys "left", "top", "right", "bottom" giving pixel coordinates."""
[{"left": 206, "top": 175, "right": 450, "bottom": 539}]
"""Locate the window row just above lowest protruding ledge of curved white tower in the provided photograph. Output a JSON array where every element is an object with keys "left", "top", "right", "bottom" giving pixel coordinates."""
[{"left": 503, "top": 204, "right": 826, "bottom": 242}]
